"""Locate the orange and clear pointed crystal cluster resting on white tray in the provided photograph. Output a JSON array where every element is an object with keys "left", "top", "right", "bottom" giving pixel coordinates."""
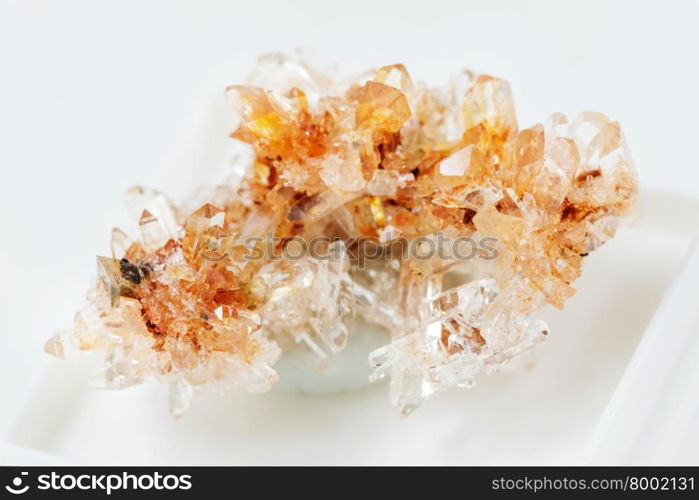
[{"left": 47, "top": 55, "right": 637, "bottom": 414}]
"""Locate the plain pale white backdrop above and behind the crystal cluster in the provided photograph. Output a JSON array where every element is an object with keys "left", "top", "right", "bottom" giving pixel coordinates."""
[{"left": 0, "top": 0, "right": 699, "bottom": 460}]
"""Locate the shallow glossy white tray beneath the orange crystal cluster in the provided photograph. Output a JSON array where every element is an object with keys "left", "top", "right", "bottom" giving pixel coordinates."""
[{"left": 0, "top": 190, "right": 699, "bottom": 465}]
